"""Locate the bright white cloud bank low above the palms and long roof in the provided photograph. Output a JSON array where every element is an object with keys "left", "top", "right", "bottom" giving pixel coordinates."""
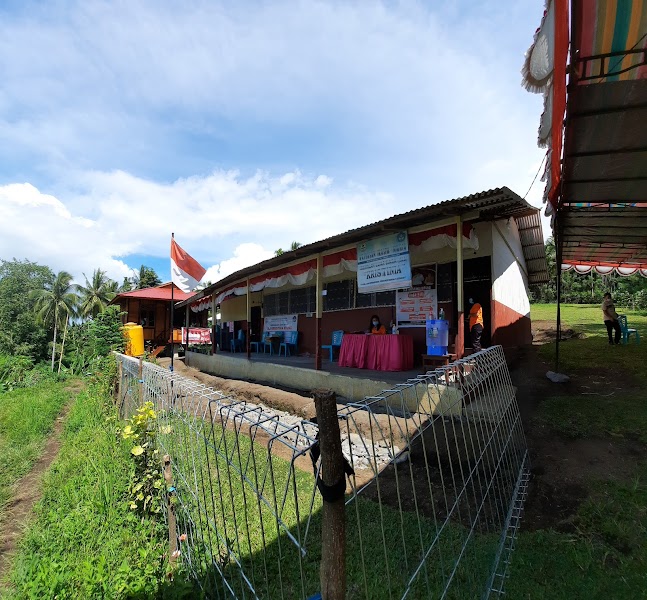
[{"left": 0, "top": 171, "right": 393, "bottom": 281}]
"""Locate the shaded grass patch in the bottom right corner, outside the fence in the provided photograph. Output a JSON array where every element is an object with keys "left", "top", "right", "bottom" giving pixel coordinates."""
[{"left": 506, "top": 464, "right": 647, "bottom": 600}]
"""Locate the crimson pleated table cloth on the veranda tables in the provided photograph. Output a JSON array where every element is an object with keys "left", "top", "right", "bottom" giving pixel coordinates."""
[{"left": 339, "top": 333, "right": 413, "bottom": 371}]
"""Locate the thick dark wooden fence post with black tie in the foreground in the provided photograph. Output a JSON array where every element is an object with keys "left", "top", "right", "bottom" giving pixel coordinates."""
[{"left": 312, "top": 390, "right": 346, "bottom": 600}]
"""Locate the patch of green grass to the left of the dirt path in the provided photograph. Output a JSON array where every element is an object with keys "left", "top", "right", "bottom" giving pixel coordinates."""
[{"left": 0, "top": 382, "right": 71, "bottom": 521}]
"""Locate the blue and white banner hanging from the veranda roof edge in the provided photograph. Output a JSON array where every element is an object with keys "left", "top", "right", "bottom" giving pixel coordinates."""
[{"left": 357, "top": 231, "right": 411, "bottom": 294}]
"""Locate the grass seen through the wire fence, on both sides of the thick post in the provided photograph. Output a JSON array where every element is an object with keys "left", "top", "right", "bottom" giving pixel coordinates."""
[{"left": 160, "top": 415, "right": 499, "bottom": 600}]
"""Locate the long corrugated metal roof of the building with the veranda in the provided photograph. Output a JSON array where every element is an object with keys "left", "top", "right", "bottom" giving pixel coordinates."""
[{"left": 177, "top": 187, "right": 539, "bottom": 308}]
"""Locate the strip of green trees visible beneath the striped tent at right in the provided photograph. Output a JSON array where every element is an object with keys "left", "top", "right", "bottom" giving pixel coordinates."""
[{"left": 531, "top": 237, "right": 647, "bottom": 309}]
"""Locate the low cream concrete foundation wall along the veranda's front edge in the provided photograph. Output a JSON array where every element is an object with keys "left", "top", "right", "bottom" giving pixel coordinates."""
[{"left": 185, "top": 352, "right": 410, "bottom": 401}]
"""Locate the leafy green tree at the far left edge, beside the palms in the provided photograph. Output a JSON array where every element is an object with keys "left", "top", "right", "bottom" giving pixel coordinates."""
[{"left": 0, "top": 259, "right": 54, "bottom": 361}]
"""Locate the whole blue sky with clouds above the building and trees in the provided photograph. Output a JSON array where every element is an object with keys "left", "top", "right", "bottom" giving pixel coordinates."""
[{"left": 0, "top": 0, "right": 549, "bottom": 283}]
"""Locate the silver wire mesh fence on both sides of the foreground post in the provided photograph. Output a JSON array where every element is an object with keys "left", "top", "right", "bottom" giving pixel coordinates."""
[{"left": 118, "top": 347, "right": 528, "bottom": 599}]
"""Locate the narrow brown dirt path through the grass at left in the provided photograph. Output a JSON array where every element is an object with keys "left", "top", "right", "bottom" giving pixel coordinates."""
[{"left": 0, "top": 383, "right": 81, "bottom": 590}]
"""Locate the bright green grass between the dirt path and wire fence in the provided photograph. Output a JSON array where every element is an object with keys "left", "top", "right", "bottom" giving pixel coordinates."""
[{"left": 4, "top": 368, "right": 195, "bottom": 599}]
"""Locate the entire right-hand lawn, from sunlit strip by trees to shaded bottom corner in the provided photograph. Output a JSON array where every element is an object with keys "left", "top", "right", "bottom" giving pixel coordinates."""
[{"left": 507, "top": 305, "right": 647, "bottom": 600}]
